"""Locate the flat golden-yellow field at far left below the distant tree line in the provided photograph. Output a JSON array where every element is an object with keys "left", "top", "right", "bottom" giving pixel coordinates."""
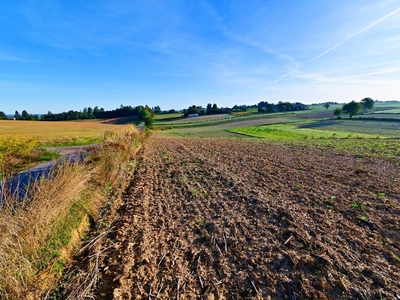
[{"left": 0, "top": 120, "right": 123, "bottom": 146}]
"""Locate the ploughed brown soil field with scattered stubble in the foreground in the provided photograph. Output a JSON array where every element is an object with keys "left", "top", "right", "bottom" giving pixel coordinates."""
[{"left": 97, "top": 138, "right": 400, "bottom": 299}]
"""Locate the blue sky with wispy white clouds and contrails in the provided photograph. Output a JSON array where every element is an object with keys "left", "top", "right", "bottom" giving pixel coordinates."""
[{"left": 0, "top": 0, "right": 400, "bottom": 114}]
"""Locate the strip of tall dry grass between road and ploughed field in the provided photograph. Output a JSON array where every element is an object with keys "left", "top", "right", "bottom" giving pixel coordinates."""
[{"left": 0, "top": 123, "right": 145, "bottom": 299}]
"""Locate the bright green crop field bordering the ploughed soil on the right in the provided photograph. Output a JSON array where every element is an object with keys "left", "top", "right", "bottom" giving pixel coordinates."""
[{"left": 229, "top": 120, "right": 400, "bottom": 160}]
